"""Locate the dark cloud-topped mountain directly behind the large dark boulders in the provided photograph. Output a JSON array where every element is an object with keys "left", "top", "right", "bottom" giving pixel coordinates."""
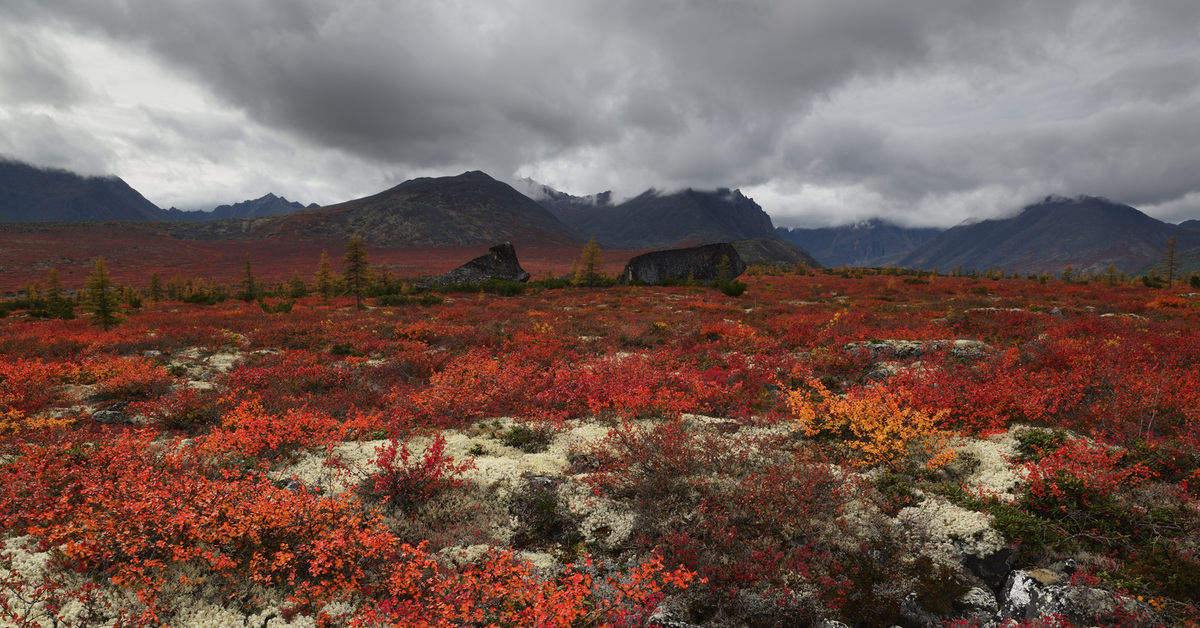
[{"left": 539, "top": 186, "right": 779, "bottom": 249}]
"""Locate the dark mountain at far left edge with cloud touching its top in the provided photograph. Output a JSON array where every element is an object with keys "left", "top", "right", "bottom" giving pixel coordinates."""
[{"left": 0, "top": 160, "right": 163, "bottom": 222}]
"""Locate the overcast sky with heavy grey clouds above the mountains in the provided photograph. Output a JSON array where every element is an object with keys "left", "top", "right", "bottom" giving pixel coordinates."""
[{"left": 0, "top": 0, "right": 1200, "bottom": 227}]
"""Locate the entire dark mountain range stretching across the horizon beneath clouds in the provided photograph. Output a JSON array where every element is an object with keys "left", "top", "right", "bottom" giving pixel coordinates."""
[{"left": 0, "top": 161, "right": 1200, "bottom": 273}]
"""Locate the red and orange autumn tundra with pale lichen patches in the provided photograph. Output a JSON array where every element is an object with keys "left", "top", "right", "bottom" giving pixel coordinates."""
[{"left": 0, "top": 262, "right": 1200, "bottom": 628}]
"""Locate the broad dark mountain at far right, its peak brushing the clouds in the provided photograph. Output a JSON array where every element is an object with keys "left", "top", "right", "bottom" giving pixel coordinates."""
[{"left": 898, "top": 196, "right": 1200, "bottom": 273}]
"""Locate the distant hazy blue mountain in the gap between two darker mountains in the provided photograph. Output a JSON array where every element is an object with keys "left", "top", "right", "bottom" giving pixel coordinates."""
[{"left": 775, "top": 220, "right": 942, "bottom": 267}]
